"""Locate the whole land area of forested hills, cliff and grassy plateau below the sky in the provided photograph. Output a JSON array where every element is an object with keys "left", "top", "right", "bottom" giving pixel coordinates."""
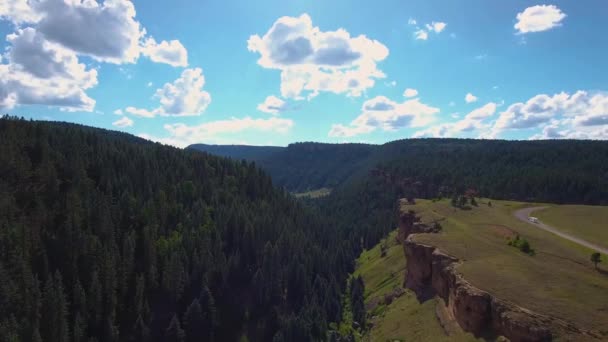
[{"left": 0, "top": 117, "right": 608, "bottom": 342}]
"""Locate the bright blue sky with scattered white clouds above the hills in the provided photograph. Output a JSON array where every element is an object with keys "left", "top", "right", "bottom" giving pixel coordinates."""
[{"left": 0, "top": 0, "right": 608, "bottom": 147}]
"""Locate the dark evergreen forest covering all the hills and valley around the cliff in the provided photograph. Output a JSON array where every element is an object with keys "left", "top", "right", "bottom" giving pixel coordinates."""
[{"left": 0, "top": 116, "right": 608, "bottom": 342}]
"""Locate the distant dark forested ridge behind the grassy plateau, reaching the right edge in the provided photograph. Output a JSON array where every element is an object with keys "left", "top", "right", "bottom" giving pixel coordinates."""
[{"left": 191, "top": 139, "right": 608, "bottom": 204}]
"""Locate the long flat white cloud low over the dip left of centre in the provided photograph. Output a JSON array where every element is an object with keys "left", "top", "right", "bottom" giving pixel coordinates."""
[{"left": 139, "top": 117, "right": 294, "bottom": 147}]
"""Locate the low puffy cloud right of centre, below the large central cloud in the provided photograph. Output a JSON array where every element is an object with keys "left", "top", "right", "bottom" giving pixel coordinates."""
[{"left": 329, "top": 96, "right": 439, "bottom": 137}]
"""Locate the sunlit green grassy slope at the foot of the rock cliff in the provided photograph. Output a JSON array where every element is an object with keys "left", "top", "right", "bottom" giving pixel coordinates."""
[{"left": 355, "top": 231, "right": 475, "bottom": 341}]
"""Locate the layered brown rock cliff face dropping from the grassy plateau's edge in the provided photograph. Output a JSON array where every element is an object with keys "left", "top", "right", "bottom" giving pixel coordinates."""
[{"left": 399, "top": 207, "right": 599, "bottom": 342}]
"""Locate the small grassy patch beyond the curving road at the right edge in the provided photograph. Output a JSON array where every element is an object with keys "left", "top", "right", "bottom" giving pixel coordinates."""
[{"left": 533, "top": 205, "right": 608, "bottom": 250}]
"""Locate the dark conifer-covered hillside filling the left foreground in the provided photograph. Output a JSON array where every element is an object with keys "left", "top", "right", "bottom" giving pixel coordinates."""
[{"left": 0, "top": 117, "right": 370, "bottom": 342}]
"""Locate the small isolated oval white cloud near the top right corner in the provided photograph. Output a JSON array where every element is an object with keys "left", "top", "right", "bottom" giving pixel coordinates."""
[{"left": 515, "top": 5, "right": 566, "bottom": 33}]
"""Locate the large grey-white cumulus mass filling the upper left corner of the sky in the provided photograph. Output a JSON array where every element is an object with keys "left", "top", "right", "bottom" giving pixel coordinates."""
[{"left": 0, "top": 0, "right": 187, "bottom": 111}]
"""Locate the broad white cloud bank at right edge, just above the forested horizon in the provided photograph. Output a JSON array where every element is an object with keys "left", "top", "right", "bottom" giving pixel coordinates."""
[{"left": 492, "top": 90, "right": 608, "bottom": 139}]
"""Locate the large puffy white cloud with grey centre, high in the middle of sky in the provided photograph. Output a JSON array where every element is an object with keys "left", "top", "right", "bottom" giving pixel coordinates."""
[{"left": 247, "top": 14, "right": 389, "bottom": 99}]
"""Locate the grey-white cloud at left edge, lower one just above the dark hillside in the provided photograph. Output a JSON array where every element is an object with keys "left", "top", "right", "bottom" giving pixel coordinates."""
[{"left": 0, "top": 27, "right": 97, "bottom": 112}]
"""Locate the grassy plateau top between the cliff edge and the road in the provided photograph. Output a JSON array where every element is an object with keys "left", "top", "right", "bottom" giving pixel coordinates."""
[{"left": 409, "top": 200, "right": 608, "bottom": 336}]
